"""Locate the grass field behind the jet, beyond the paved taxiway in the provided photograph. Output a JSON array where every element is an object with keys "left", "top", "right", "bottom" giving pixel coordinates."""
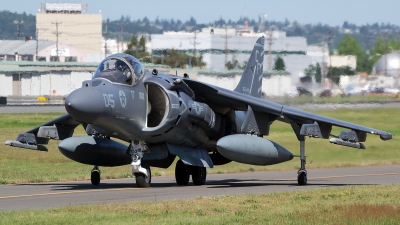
[{"left": 0, "top": 108, "right": 400, "bottom": 184}]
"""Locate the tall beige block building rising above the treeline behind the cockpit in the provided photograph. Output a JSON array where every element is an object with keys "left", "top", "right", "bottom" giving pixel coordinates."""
[{"left": 36, "top": 3, "right": 104, "bottom": 62}]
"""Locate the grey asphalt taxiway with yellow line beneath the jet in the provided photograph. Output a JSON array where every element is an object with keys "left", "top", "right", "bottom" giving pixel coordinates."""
[{"left": 0, "top": 165, "right": 400, "bottom": 211}]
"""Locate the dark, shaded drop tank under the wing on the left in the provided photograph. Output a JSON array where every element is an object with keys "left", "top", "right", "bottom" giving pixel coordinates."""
[{"left": 58, "top": 136, "right": 132, "bottom": 166}]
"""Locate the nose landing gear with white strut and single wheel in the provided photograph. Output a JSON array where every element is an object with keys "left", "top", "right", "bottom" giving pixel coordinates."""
[{"left": 130, "top": 141, "right": 151, "bottom": 188}]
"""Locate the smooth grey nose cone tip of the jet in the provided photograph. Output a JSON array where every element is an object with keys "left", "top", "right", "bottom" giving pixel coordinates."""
[{"left": 65, "top": 88, "right": 104, "bottom": 123}]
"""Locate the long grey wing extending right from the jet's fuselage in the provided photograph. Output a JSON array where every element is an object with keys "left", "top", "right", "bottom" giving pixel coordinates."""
[{"left": 184, "top": 79, "right": 393, "bottom": 142}]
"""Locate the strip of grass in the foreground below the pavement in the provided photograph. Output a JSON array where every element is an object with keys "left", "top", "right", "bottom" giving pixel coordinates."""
[{"left": 0, "top": 185, "right": 400, "bottom": 225}]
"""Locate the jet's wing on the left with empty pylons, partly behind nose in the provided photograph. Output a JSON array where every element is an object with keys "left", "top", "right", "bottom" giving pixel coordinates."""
[{"left": 5, "top": 114, "right": 85, "bottom": 151}]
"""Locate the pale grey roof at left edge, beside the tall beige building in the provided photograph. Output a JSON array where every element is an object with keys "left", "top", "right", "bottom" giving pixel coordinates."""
[{"left": 0, "top": 40, "right": 56, "bottom": 55}]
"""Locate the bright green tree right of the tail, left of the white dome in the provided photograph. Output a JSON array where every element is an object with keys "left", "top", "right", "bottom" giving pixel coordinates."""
[{"left": 338, "top": 34, "right": 367, "bottom": 72}]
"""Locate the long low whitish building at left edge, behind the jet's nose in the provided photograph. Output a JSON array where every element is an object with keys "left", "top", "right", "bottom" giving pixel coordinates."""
[{"left": 0, "top": 61, "right": 97, "bottom": 96}]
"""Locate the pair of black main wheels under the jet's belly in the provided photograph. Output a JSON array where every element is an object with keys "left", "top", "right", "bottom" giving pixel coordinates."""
[{"left": 175, "top": 160, "right": 207, "bottom": 185}]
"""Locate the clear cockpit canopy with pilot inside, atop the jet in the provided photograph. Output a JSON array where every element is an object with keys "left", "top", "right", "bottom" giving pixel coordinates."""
[{"left": 93, "top": 54, "right": 144, "bottom": 85}]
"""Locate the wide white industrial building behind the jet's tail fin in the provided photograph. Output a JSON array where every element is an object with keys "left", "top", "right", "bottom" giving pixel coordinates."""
[{"left": 151, "top": 28, "right": 312, "bottom": 83}]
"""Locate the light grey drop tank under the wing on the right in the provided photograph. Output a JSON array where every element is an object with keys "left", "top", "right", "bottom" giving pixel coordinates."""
[{"left": 217, "top": 134, "right": 293, "bottom": 166}]
